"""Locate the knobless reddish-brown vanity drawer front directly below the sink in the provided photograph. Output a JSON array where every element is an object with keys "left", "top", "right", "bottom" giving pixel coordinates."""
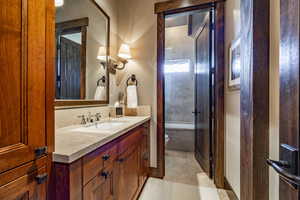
[{"left": 119, "top": 127, "right": 143, "bottom": 154}]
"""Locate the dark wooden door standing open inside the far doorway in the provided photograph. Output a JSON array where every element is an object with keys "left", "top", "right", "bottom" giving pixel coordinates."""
[{"left": 195, "top": 14, "right": 212, "bottom": 177}]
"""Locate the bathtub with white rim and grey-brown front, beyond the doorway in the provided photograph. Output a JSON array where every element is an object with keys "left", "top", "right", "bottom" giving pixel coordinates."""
[{"left": 165, "top": 122, "right": 195, "bottom": 152}]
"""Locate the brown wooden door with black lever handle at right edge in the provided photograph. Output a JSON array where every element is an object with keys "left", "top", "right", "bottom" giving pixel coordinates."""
[{"left": 279, "top": 0, "right": 300, "bottom": 200}]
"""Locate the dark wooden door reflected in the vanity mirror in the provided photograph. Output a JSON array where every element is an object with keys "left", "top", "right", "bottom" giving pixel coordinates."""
[{"left": 58, "top": 36, "right": 81, "bottom": 99}]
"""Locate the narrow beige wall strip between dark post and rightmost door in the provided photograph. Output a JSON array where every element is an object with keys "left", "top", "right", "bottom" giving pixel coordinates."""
[{"left": 269, "top": 0, "right": 280, "bottom": 200}]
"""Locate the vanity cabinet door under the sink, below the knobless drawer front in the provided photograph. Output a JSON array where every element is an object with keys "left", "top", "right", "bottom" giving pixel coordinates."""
[{"left": 118, "top": 147, "right": 139, "bottom": 200}]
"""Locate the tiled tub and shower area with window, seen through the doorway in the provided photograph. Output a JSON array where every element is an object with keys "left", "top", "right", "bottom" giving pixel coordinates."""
[{"left": 164, "top": 11, "right": 204, "bottom": 152}]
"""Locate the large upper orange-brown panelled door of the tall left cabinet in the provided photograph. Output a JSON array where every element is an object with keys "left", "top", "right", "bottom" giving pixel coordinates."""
[{"left": 0, "top": 0, "right": 46, "bottom": 173}]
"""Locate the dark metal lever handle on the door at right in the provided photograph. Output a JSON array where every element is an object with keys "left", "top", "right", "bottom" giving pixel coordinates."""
[{"left": 267, "top": 159, "right": 300, "bottom": 189}]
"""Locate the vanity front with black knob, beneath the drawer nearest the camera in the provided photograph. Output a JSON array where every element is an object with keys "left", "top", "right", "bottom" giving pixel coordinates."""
[{"left": 83, "top": 168, "right": 114, "bottom": 200}]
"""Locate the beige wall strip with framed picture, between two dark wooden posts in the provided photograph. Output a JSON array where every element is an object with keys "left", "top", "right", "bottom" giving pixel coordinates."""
[{"left": 225, "top": 0, "right": 241, "bottom": 197}]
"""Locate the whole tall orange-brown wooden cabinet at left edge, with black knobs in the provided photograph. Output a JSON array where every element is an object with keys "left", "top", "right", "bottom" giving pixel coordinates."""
[{"left": 0, "top": 0, "right": 54, "bottom": 200}]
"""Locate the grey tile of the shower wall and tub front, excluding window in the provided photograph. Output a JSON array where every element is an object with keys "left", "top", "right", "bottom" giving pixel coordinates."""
[{"left": 165, "top": 25, "right": 195, "bottom": 151}]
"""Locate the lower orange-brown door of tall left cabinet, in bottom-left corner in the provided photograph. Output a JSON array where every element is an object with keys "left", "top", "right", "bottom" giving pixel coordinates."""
[{"left": 0, "top": 167, "right": 46, "bottom": 200}]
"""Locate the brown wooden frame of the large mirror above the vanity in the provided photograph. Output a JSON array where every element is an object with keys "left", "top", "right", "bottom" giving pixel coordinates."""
[{"left": 54, "top": 0, "right": 110, "bottom": 107}]
